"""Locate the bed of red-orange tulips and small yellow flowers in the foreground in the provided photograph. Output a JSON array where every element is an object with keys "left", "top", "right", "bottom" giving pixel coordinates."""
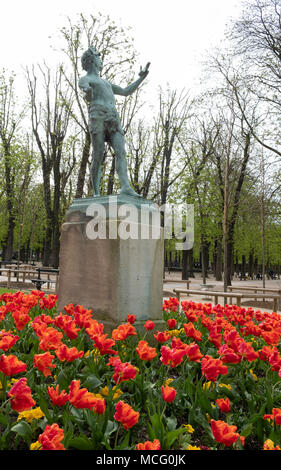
[{"left": 0, "top": 291, "right": 281, "bottom": 450}]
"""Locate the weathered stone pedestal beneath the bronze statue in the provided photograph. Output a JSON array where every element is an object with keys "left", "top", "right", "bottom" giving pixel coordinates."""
[{"left": 58, "top": 195, "right": 164, "bottom": 332}]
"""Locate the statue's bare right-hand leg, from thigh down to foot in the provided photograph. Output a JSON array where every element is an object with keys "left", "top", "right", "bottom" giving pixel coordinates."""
[{"left": 111, "top": 132, "right": 141, "bottom": 197}]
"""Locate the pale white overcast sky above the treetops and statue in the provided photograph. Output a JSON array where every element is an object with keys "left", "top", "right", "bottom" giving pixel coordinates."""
[{"left": 0, "top": 0, "right": 242, "bottom": 97}]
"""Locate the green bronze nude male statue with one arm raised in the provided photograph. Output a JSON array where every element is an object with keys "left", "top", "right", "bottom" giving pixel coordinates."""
[{"left": 79, "top": 46, "right": 150, "bottom": 197}]
